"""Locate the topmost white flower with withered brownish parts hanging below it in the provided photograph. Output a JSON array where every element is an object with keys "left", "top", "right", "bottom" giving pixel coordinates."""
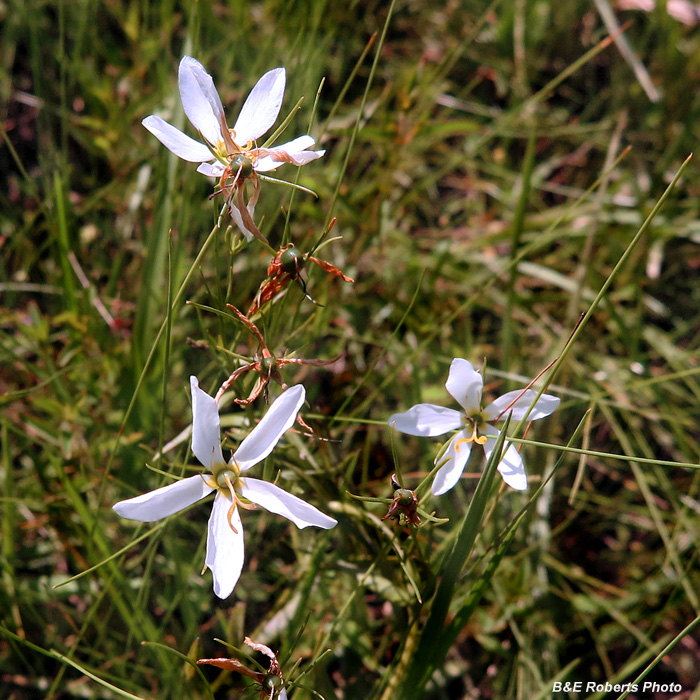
[{"left": 142, "top": 56, "right": 325, "bottom": 240}]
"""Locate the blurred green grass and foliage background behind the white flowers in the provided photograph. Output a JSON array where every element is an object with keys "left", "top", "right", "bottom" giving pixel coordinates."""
[{"left": 0, "top": 0, "right": 700, "bottom": 700}]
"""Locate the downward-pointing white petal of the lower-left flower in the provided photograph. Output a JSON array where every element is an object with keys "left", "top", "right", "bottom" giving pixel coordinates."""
[{"left": 204, "top": 491, "right": 245, "bottom": 598}]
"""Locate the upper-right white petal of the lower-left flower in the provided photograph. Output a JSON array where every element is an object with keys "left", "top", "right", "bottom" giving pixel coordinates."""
[{"left": 232, "top": 384, "right": 306, "bottom": 471}]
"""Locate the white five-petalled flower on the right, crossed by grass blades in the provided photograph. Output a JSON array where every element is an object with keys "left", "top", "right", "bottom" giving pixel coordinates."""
[{"left": 389, "top": 357, "right": 559, "bottom": 496}]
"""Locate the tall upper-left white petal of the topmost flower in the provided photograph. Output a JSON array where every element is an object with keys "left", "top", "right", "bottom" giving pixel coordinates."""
[{"left": 178, "top": 56, "right": 226, "bottom": 146}]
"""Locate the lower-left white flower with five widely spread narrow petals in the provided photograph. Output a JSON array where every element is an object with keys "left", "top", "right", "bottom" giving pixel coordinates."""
[{"left": 114, "top": 377, "right": 337, "bottom": 598}]
